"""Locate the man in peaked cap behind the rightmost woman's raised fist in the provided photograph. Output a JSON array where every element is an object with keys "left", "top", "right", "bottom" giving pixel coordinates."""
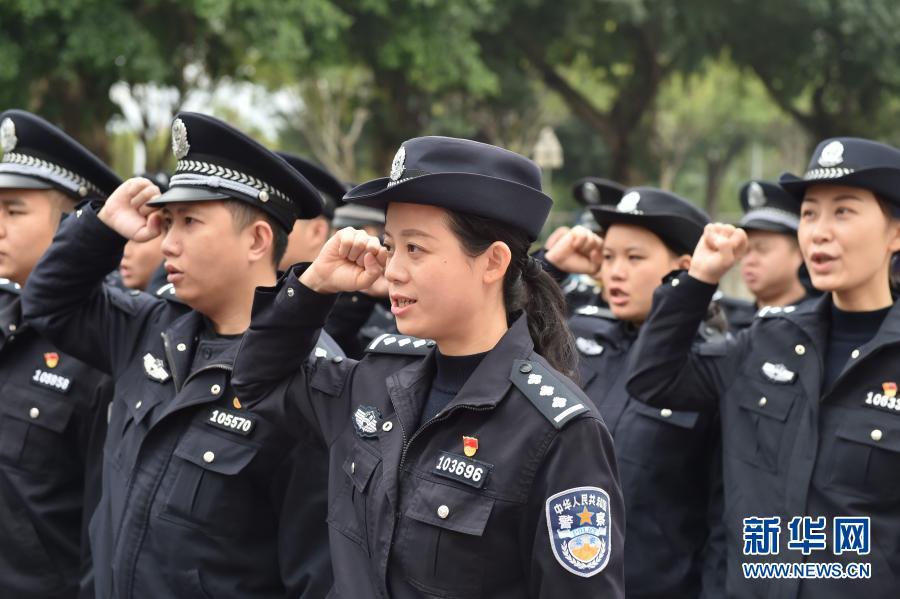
[{"left": 720, "top": 181, "right": 809, "bottom": 331}]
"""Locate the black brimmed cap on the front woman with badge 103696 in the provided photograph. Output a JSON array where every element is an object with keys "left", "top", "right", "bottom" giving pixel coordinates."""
[{"left": 344, "top": 137, "right": 553, "bottom": 241}]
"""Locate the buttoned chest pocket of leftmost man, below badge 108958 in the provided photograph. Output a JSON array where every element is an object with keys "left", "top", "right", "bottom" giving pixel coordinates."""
[{"left": 0, "top": 387, "right": 75, "bottom": 471}]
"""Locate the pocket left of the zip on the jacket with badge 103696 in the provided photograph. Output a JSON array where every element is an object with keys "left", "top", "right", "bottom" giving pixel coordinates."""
[{"left": 327, "top": 443, "right": 381, "bottom": 552}]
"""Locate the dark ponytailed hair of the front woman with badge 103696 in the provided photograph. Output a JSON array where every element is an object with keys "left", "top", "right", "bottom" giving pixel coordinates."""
[{"left": 447, "top": 211, "right": 577, "bottom": 379}]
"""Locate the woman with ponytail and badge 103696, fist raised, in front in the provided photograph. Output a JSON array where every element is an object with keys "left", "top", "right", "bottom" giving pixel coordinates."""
[{"left": 236, "top": 137, "right": 624, "bottom": 598}]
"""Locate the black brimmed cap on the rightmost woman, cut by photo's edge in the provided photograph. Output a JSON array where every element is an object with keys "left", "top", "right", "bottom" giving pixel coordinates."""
[{"left": 778, "top": 137, "right": 900, "bottom": 208}]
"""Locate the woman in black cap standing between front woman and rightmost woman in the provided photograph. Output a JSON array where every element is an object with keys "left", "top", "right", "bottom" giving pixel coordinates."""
[{"left": 546, "top": 187, "right": 725, "bottom": 599}]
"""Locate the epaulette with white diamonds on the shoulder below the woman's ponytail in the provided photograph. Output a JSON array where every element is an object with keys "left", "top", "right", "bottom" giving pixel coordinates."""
[{"left": 509, "top": 360, "right": 588, "bottom": 429}]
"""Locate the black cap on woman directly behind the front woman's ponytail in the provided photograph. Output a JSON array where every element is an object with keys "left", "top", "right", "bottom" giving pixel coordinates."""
[{"left": 591, "top": 187, "right": 709, "bottom": 255}]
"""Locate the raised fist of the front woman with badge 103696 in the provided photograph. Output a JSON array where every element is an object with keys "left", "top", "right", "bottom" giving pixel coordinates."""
[{"left": 300, "top": 227, "right": 387, "bottom": 293}]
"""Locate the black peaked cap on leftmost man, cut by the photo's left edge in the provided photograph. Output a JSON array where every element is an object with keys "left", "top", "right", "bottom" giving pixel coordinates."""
[{"left": 0, "top": 109, "right": 122, "bottom": 200}]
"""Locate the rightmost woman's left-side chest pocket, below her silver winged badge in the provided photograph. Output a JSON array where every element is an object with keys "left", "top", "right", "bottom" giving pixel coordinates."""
[{"left": 722, "top": 377, "right": 798, "bottom": 472}]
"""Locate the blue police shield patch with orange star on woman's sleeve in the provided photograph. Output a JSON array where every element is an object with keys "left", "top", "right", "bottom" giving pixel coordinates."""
[{"left": 546, "top": 487, "right": 610, "bottom": 578}]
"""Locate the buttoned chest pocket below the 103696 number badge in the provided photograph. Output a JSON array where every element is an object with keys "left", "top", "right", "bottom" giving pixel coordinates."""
[{"left": 394, "top": 479, "right": 492, "bottom": 599}]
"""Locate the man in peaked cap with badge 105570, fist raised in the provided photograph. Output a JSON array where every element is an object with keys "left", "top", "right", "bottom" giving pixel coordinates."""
[{"left": 23, "top": 113, "right": 331, "bottom": 599}]
